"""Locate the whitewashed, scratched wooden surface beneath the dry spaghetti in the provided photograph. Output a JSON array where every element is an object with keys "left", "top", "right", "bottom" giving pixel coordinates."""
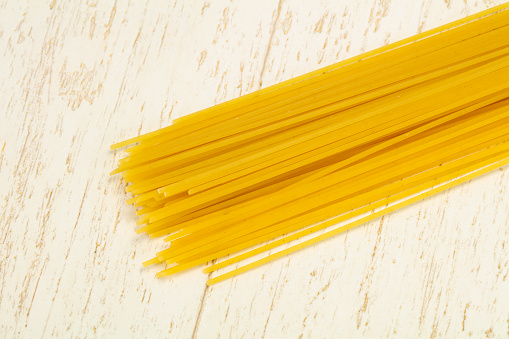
[{"left": 0, "top": 0, "right": 509, "bottom": 338}]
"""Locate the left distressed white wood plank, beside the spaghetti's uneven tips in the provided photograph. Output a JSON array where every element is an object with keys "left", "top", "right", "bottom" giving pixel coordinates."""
[{"left": 0, "top": 1, "right": 275, "bottom": 337}]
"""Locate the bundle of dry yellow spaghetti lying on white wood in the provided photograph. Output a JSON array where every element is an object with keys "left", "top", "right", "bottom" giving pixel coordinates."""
[{"left": 112, "top": 4, "right": 509, "bottom": 284}]
